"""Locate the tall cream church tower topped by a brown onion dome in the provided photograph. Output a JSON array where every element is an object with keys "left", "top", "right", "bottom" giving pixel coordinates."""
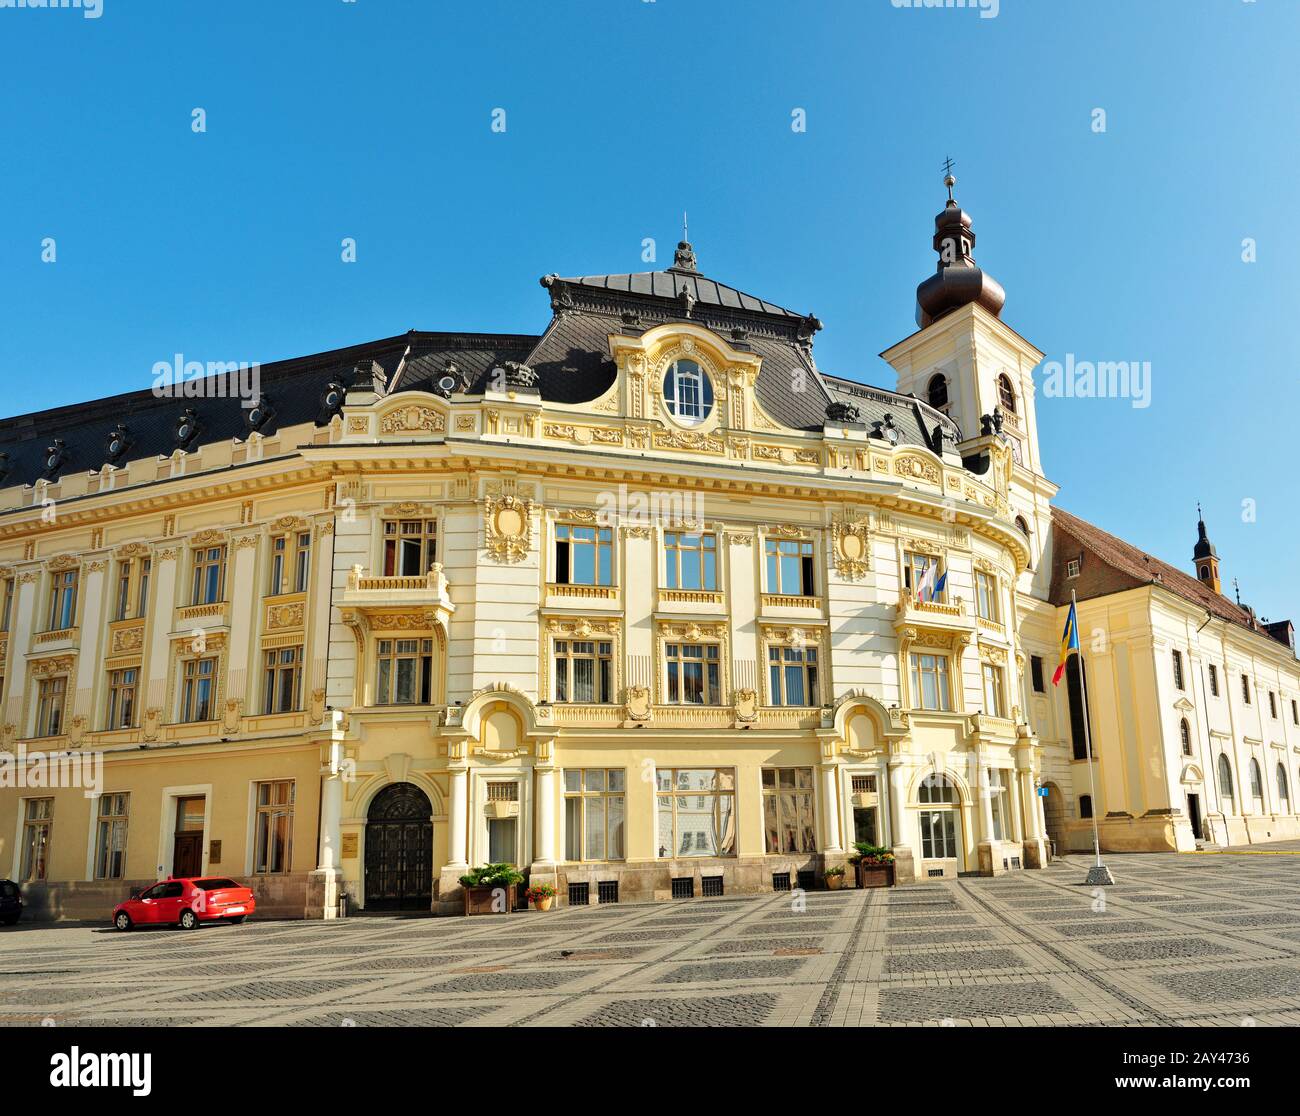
[{"left": 880, "top": 164, "right": 1057, "bottom": 577}]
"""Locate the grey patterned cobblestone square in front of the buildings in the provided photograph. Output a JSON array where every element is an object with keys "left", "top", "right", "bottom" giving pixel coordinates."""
[{"left": 0, "top": 853, "right": 1300, "bottom": 1028}]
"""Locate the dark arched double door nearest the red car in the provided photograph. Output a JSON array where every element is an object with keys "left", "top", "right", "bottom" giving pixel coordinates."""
[{"left": 365, "top": 783, "right": 433, "bottom": 910}]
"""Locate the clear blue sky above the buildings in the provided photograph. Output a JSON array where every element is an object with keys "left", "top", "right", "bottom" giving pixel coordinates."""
[{"left": 0, "top": 0, "right": 1300, "bottom": 619}]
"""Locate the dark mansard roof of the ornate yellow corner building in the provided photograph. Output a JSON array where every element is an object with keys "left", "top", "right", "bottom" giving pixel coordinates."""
[{"left": 0, "top": 243, "right": 959, "bottom": 486}]
